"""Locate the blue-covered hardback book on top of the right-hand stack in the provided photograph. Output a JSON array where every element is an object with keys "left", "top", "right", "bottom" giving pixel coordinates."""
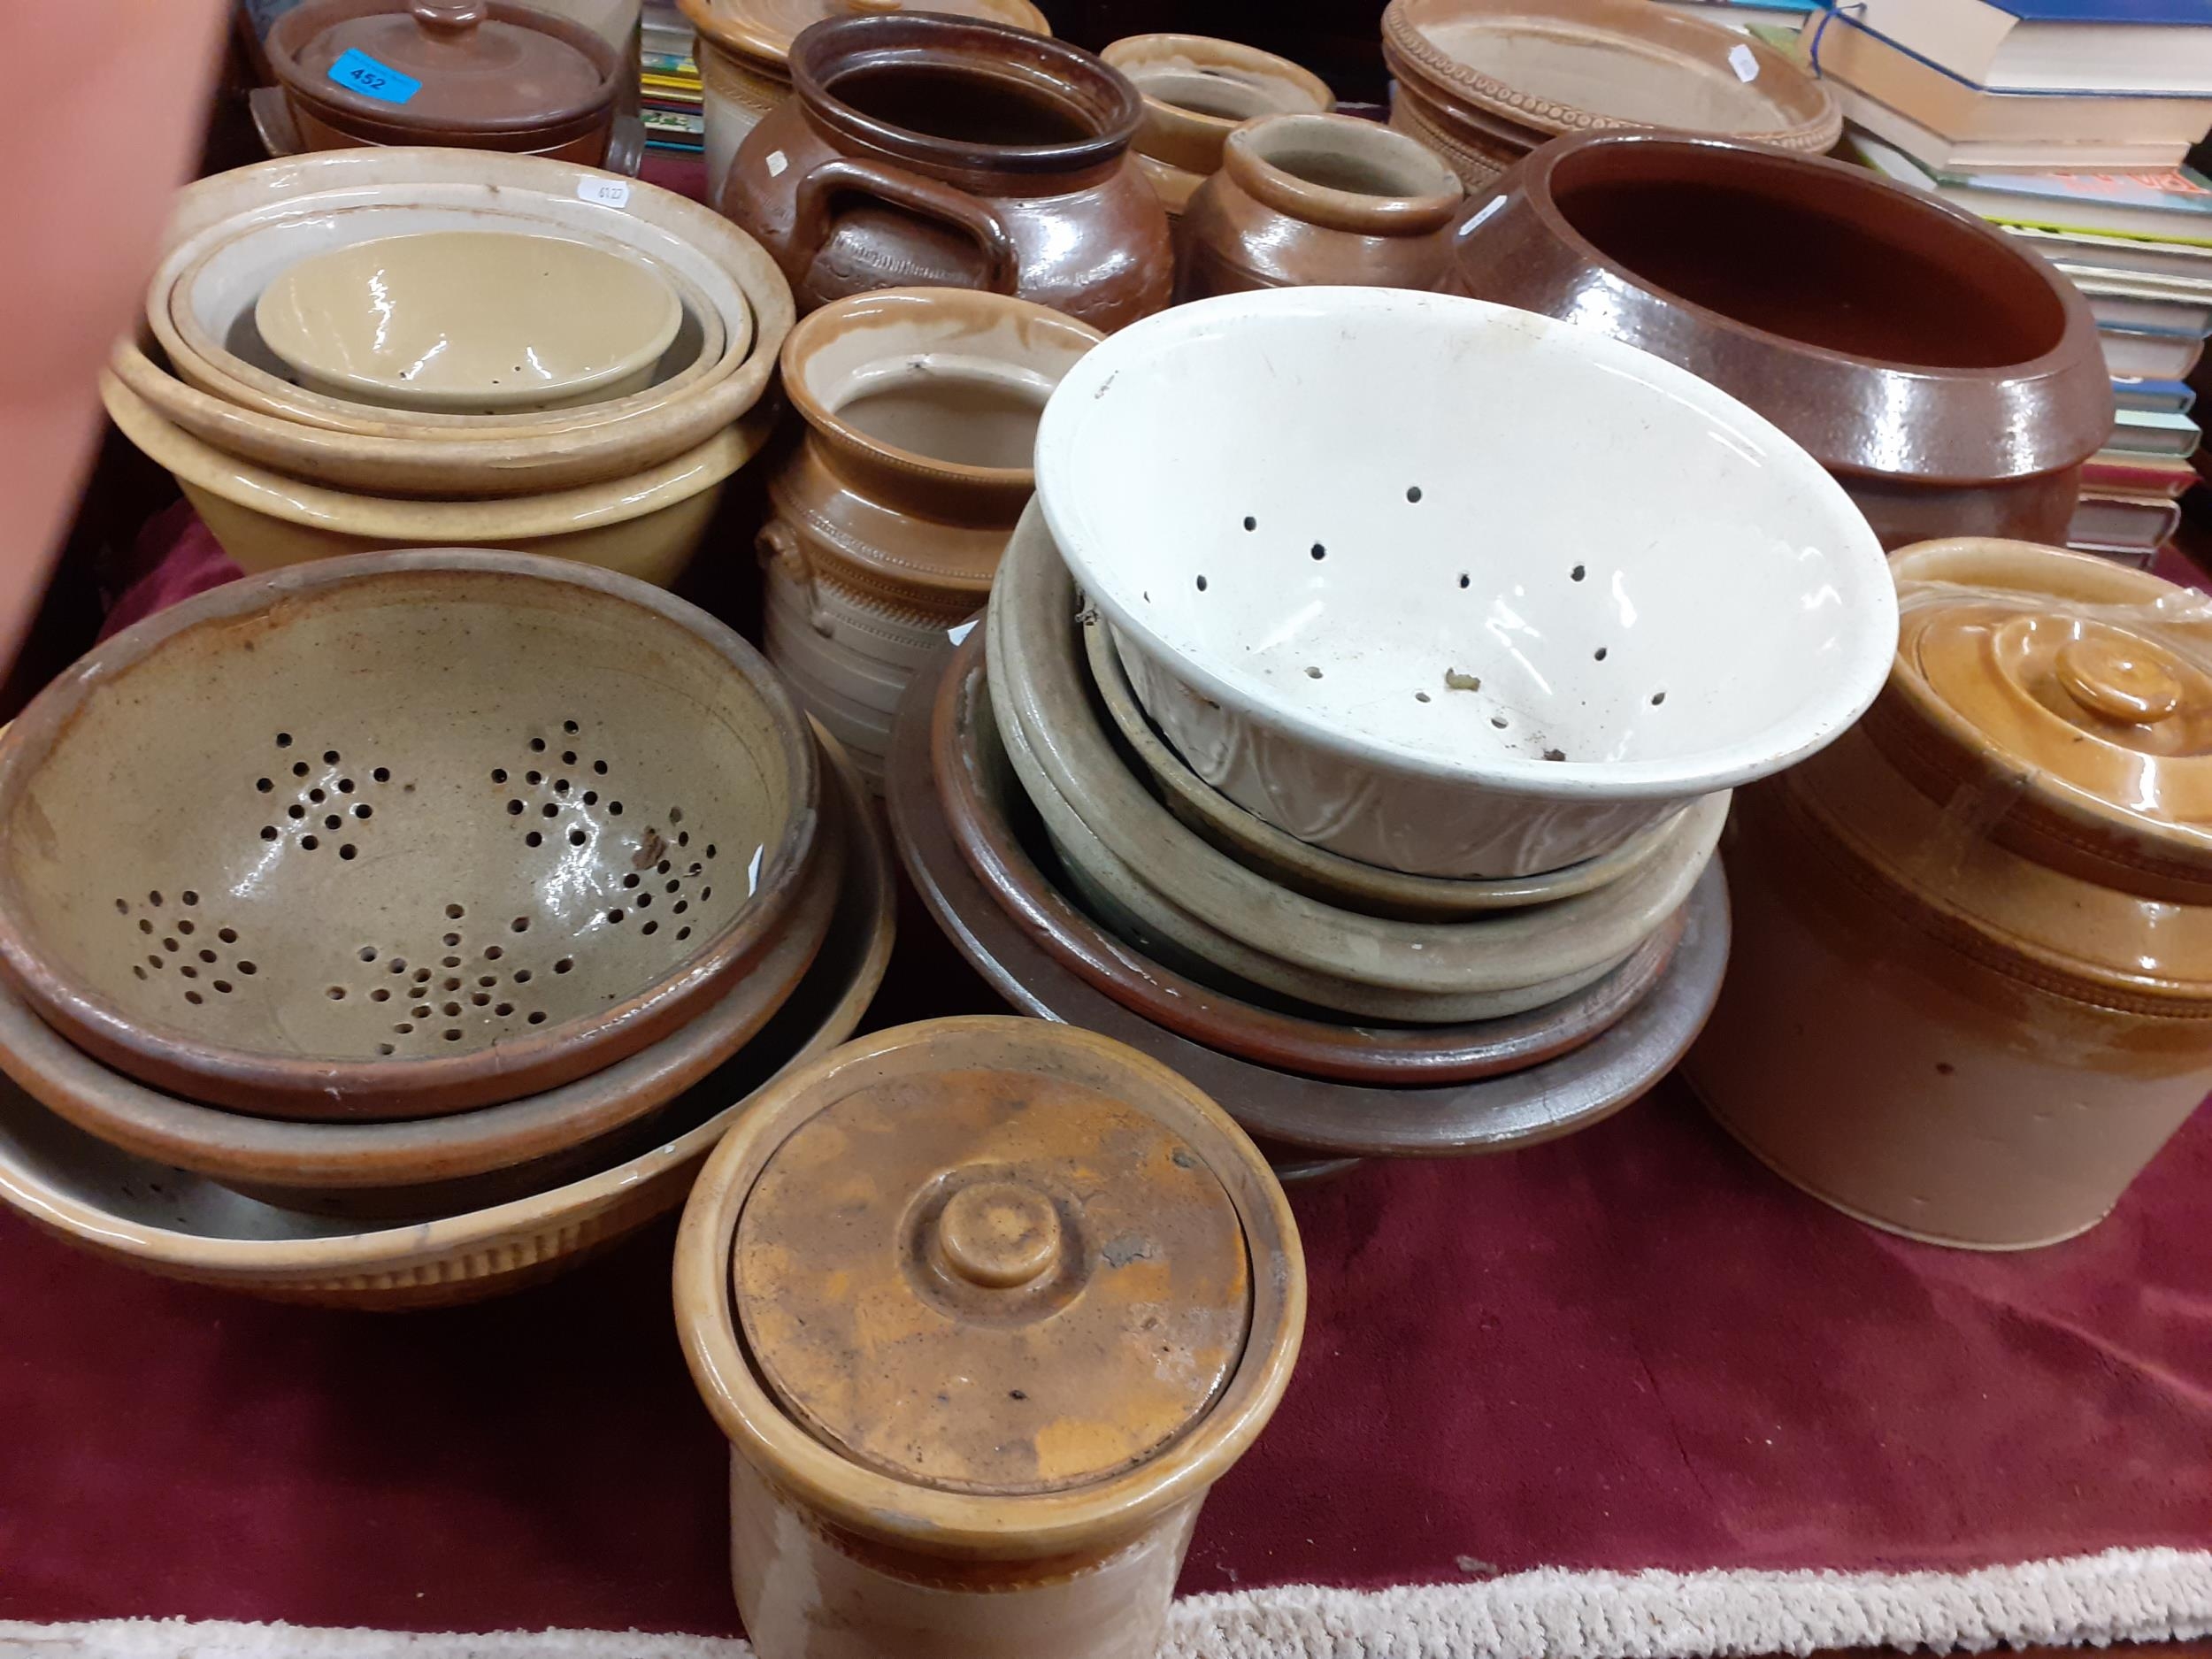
[{"left": 1823, "top": 0, "right": 2212, "bottom": 93}]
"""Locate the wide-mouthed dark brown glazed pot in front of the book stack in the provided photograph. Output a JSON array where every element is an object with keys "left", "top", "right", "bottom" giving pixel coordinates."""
[{"left": 1445, "top": 133, "right": 2113, "bottom": 549}]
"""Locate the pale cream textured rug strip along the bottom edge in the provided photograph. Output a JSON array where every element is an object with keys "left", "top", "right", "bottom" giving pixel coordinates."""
[{"left": 0, "top": 1548, "right": 2212, "bottom": 1659}]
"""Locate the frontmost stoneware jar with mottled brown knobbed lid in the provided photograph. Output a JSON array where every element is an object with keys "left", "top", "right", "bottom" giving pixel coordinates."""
[{"left": 675, "top": 1016, "right": 1305, "bottom": 1659}]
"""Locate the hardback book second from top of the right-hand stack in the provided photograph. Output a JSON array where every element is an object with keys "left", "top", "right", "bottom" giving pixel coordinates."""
[{"left": 1799, "top": 12, "right": 2212, "bottom": 142}]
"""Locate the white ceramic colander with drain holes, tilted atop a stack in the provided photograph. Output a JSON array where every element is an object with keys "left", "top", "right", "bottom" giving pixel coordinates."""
[{"left": 1038, "top": 288, "right": 1896, "bottom": 876}]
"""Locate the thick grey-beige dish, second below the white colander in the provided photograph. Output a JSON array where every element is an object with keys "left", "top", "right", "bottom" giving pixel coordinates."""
[{"left": 989, "top": 506, "right": 1728, "bottom": 1022}]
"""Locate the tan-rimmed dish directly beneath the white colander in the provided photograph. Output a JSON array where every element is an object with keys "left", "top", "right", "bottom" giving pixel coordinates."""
[{"left": 1084, "top": 611, "right": 1681, "bottom": 923}]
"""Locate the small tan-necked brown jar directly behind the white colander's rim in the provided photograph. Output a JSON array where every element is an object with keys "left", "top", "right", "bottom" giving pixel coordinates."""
[{"left": 1175, "top": 115, "right": 1464, "bottom": 301}]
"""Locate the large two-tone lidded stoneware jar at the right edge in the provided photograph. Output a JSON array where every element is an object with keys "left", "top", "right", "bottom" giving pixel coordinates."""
[{"left": 1686, "top": 540, "right": 2212, "bottom": 1250}]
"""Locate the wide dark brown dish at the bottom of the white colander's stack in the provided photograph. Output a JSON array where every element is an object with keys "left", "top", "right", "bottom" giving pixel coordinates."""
[{"left": 887, "top": 655, "right": 1728, "bottom": 1157}]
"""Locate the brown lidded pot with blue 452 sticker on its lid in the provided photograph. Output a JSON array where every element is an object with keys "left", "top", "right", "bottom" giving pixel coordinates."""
[{"left": 265, "top": 0, "right": 628, "bottom": 166}]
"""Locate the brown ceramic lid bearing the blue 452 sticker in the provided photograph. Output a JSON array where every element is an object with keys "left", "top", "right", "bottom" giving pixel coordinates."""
[{"left": 273, "top": 0, "right": 615, "bottom": 133}]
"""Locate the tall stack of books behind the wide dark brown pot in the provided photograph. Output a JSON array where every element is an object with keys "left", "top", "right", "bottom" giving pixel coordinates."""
[{"left": 1799, "top": 0, "right": 2212, "bottom": 565}]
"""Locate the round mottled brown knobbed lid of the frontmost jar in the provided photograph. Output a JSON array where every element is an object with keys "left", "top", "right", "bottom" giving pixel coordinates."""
[{"left": 733, "top": 1022, "right": 1252, "bottom": 1495}]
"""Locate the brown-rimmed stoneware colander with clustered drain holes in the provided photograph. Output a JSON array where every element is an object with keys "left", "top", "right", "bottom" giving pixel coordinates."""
[{"left": 0, "top": 551, "right": 818, "bottom": 1118}]
